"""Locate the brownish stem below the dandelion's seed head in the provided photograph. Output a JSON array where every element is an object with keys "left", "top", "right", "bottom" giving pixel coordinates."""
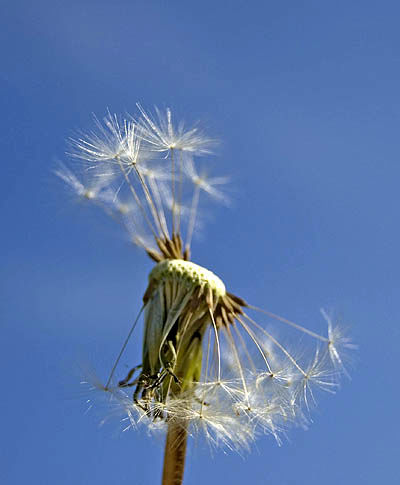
[{"left": 162, "top": 420, "right": 188, "bottom": 485}]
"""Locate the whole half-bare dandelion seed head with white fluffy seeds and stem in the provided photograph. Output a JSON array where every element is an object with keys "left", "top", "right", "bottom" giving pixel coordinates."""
[{"left": 56, "top": 105, "right": 354, "bottom": 485}]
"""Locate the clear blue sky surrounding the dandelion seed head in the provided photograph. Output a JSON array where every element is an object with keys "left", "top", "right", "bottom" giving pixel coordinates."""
[{"left": 0, "top": 0, "right": 400, "bottom": 485}]
